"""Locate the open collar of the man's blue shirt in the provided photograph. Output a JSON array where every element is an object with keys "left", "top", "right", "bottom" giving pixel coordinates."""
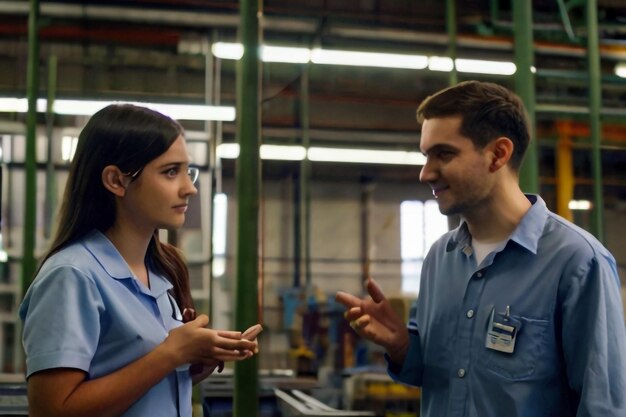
[{"left": 446, "top": 194, "right": 548, "bottom": 254}]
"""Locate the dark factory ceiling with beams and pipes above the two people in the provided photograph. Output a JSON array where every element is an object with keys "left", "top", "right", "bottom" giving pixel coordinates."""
[{"left": 0, "top": 0, "right": 626, "bottom": 199}]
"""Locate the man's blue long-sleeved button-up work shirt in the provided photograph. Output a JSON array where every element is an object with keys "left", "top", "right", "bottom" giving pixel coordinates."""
[{"left": 389, "top": 195, "right": 626, "bottom": 417}]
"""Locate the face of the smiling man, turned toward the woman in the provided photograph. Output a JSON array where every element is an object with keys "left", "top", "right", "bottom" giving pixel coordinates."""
[{"left": 420, "top": 116, "right": 494, "bottom": 216}]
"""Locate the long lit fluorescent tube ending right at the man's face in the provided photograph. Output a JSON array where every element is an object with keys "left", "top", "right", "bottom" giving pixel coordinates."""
[{"left": 307, "top": 147, "right": 426, "bottom": 165}]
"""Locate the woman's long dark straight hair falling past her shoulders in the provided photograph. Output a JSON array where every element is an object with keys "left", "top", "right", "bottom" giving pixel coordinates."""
[{"left": 42, "top": 104, "right": 193, "bottom": 309}]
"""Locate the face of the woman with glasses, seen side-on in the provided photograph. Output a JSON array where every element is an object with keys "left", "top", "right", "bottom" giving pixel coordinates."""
[{"left": 118, "top": 136, "right": 198, "bottom": 232}]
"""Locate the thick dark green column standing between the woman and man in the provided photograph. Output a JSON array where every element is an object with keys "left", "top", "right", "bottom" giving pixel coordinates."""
[{"left": 233, "top": 0, "right": 261, "bottom": 417}]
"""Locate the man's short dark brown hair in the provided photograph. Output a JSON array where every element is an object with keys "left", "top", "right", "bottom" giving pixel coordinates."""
[{"left": 417, "top": 81, "right": 530, "bottom": 171}]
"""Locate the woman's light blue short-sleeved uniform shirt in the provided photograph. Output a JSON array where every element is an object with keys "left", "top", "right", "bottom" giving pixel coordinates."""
[{"left": 19, "top": 231, "right": 191, "bottom": 417}]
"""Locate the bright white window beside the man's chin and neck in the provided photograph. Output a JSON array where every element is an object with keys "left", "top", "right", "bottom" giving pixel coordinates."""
[{"left": 400, "top": 200, "right": 448, "bottom": 295}]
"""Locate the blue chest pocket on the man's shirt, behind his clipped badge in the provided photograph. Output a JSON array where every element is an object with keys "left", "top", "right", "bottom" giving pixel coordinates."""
[{"left": 478, "top": 315, "right": 556, "bottom": 380}]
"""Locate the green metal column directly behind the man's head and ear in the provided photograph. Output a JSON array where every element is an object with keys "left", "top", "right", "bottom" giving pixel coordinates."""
[{"left": 512, "top": 0, "right": 539, "bottom": 193}]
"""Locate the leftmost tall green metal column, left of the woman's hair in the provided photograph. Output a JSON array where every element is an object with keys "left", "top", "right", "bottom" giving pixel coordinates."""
[{"left": 22, "top": 0, "right": 39, "bottom": 295}]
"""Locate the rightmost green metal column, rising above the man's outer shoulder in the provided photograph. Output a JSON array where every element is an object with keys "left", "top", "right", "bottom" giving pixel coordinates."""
[{"left": 587, "top": 0, "right": 604, "bottom": 242}]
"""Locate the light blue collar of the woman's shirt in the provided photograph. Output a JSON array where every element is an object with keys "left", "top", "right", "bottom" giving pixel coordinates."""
[{"left": 82, "top": 230, "right": 173, "bottom": 297}]
